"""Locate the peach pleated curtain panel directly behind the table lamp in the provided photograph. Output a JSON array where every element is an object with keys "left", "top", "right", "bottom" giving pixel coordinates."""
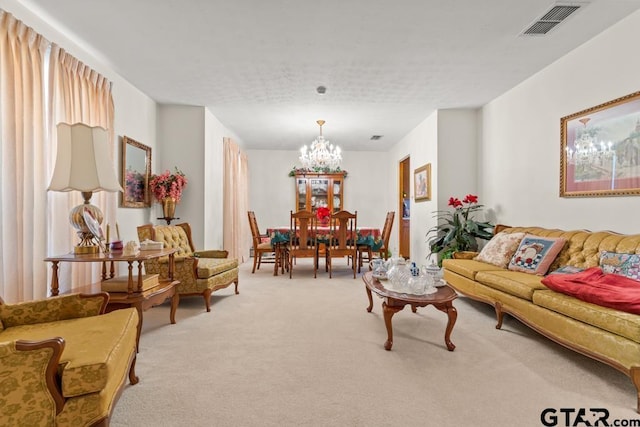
[{"left": 47, "top": 44, "right": 118, "bottom": 292}]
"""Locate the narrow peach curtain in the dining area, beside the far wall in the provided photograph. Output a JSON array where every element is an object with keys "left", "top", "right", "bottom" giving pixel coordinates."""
[{"left": 223, "top": 138, "right": 251, "bottom": 262}]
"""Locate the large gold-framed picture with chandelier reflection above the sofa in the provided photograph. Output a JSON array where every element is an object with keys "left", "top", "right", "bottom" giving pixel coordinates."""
[{"left": 560, "top": 92, "right": 640, "bottom": 197}]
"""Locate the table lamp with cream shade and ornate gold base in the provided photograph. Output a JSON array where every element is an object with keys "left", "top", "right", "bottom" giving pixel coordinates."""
[{"left": 48, "top": 123, "right": 123, "bottom": 254}]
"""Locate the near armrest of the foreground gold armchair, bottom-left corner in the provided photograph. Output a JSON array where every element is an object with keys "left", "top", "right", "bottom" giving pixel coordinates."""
[{"left": 0, "top": 337, "right": 65, "bottom": 425}]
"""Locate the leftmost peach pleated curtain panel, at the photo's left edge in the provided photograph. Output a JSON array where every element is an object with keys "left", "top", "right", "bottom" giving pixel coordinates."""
[{"left": 0, "top": 10, "right": 50, "bottom": 302}]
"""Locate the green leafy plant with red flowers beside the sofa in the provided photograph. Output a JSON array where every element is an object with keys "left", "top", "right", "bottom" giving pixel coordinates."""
[{"left": 427, "top": 194, "right": 494, "bottom": 266}]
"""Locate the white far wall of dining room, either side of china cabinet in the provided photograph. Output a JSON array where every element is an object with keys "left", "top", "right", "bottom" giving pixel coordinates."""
[{"left": 245, "top": 150, "right": 391, "bottom": 233}]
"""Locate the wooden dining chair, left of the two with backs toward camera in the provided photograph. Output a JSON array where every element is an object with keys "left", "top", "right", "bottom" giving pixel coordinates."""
[{"left": 286, "top": 210, "right": 318, "bottom": 278}]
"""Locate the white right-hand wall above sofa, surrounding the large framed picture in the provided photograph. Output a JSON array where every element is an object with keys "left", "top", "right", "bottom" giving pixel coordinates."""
[{"left": 479, "top": 8, "right": 640, "bottom": 233}]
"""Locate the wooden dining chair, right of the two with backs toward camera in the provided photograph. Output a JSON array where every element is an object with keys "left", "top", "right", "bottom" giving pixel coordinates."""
[{"left": 325, "top": 210, "right": 358, "bottom": 279}]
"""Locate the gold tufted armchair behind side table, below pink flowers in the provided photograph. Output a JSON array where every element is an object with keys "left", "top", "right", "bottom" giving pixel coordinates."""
[{"left": 138, "top": 223, "right": 239, "bottom": 311}]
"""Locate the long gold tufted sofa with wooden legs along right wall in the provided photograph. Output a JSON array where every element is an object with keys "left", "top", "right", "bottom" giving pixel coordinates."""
[{"left": 443, "top": 226, "right": 640, "bottom": 412}]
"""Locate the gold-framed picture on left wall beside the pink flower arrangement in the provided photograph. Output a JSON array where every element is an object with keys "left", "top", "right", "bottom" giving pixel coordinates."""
[{"left": 121, "top": 136, "right": 151, "bottom": 208}]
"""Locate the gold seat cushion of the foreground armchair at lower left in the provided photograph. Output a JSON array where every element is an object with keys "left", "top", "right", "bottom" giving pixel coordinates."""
[{"left": 0, "top": 308, "right": 138, "bottom": 397}]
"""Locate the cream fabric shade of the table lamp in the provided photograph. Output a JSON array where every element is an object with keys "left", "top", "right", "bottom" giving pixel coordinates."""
[{"left": 48, "top": 123, "right": 123, "bottom": 192}]
